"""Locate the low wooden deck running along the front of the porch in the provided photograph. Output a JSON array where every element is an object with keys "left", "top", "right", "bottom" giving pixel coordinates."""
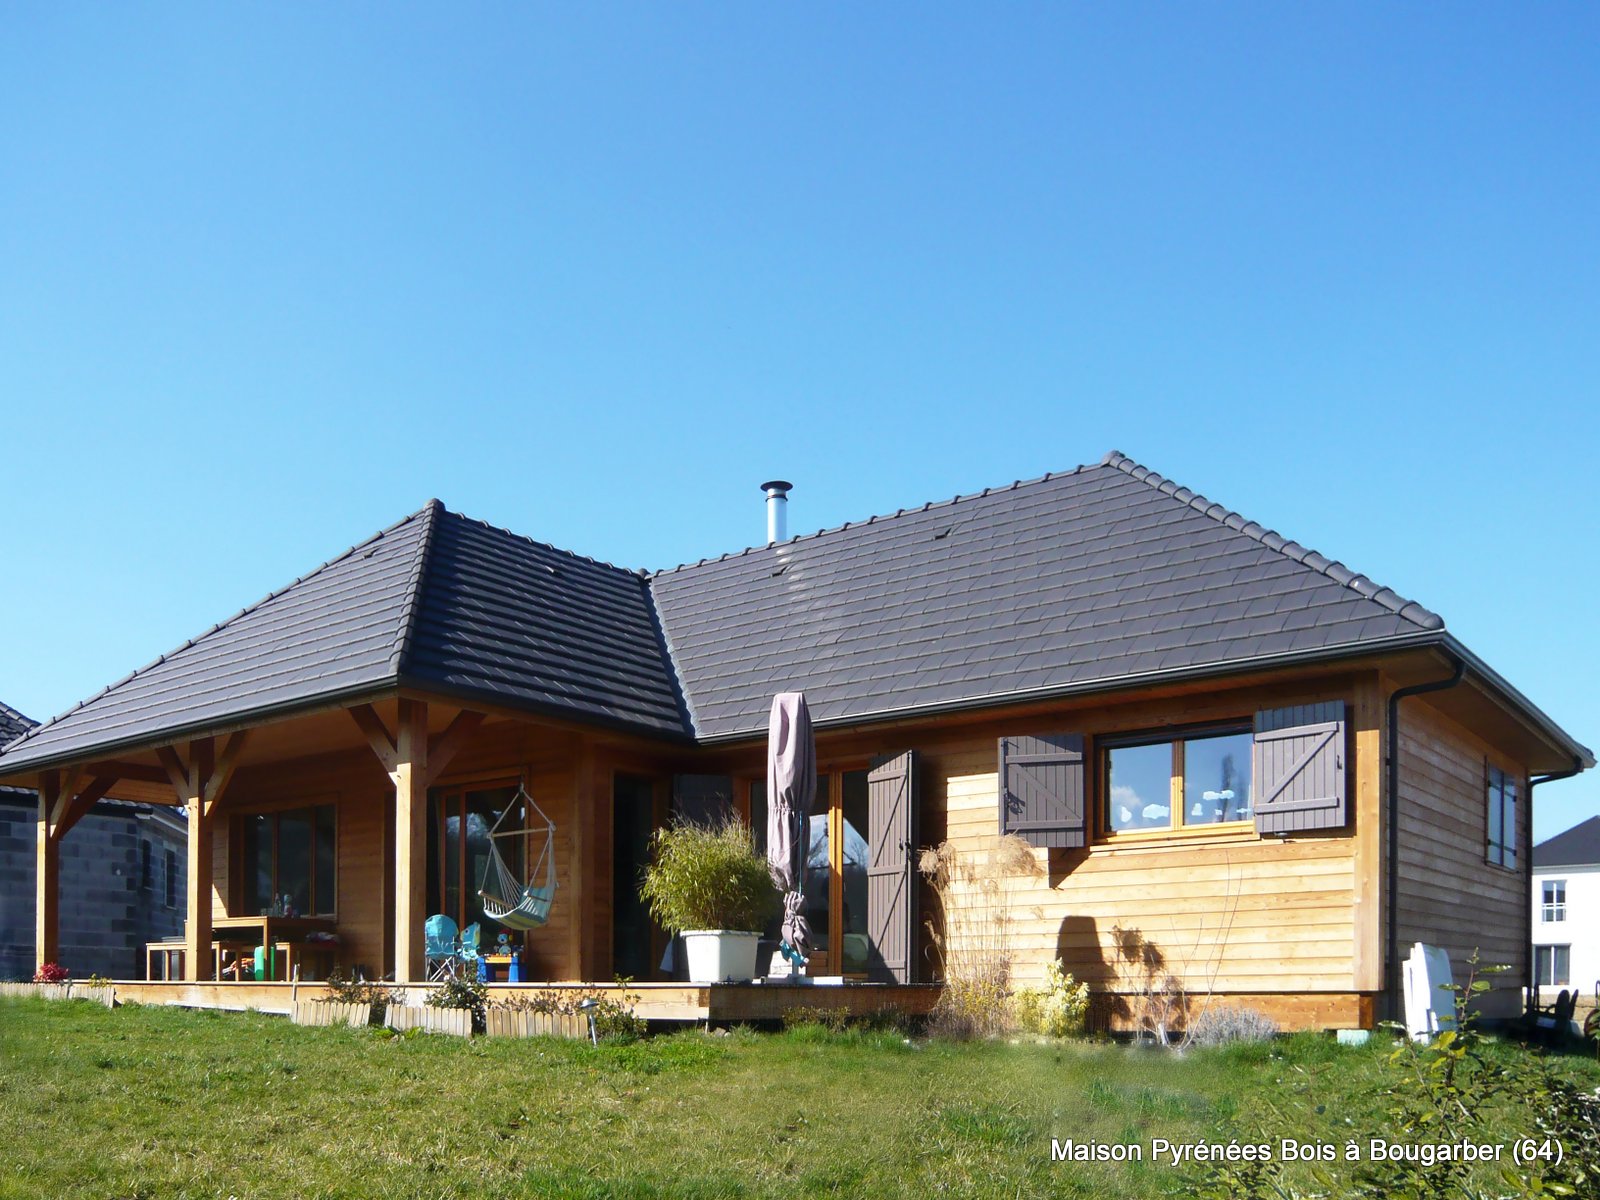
[{"left": 56, "top": 979, "right": 939, "bottom": 1024}]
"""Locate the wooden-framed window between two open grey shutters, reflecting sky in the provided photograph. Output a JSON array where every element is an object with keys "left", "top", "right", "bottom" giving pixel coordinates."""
[{"left": 1101, "top": 728, "right": 1251, "bottom": 834}]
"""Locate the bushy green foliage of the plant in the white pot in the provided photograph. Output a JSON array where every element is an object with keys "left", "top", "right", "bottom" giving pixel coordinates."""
[{"left": 640, "top": 819, "right": 779, "bottom": 933}]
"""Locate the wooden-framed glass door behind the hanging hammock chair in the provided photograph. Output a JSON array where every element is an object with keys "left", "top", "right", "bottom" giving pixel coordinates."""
[{"left": 427, "top": 781, "right": 526, "bottom": 947}]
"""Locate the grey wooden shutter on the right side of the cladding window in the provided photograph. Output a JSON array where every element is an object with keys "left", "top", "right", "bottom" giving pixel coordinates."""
[{"left": 1251, "top": 701, "right": 1347, "bottom": 834}]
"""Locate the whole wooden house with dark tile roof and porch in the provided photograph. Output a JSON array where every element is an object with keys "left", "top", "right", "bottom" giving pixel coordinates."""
[{"left": 0, "top": 453, "right": 1594, "bottom": 1027}]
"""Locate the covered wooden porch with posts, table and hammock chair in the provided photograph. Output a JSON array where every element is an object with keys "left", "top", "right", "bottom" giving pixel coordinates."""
[{"left": 13, "top": 693, "right": 697, "bottom": 1008}]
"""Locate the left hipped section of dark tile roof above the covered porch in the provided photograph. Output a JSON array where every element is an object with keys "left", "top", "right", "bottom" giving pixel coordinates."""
[{"left": 0, "top": 501, "right": 685, "bottom": 768}]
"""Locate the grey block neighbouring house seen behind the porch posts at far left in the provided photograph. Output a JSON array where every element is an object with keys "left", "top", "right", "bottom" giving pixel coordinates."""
[{"left": 0, "top": 704, "right": 187, "bottom": 979}]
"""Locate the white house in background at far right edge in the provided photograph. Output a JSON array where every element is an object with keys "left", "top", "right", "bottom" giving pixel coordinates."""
[{"left": 1533, "top": 816, "right": 1600, "bottom": 1002}]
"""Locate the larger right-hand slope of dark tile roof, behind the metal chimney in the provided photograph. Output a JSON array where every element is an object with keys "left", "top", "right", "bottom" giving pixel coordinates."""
[{"left": 653, "top": 451, "right": 1443, "bottom": 738}]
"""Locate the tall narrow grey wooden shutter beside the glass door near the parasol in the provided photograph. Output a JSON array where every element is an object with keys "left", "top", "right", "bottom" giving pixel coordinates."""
[{"left": 867, "top": 750, "right": 917, "bottom": 984}]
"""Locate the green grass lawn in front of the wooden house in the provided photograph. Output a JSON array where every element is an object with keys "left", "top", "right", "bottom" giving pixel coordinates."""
[{"left": 0, "top": 1000, "right": 1600, "bottom": 1200}]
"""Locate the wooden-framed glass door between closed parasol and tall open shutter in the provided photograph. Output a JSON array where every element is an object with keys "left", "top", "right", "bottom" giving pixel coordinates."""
[{"left": 747, "top": 770, "right": 870, "bottom": 976}]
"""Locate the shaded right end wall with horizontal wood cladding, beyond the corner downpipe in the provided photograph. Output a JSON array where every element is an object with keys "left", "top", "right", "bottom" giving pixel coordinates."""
[{"left": 1397, "top": 701, "right": 1530, "bottom": 1016}]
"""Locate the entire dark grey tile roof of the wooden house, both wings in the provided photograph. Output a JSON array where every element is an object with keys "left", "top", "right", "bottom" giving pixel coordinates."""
[{"left": 0, "top": 451, "right": 1587, "bottom": 770}]
